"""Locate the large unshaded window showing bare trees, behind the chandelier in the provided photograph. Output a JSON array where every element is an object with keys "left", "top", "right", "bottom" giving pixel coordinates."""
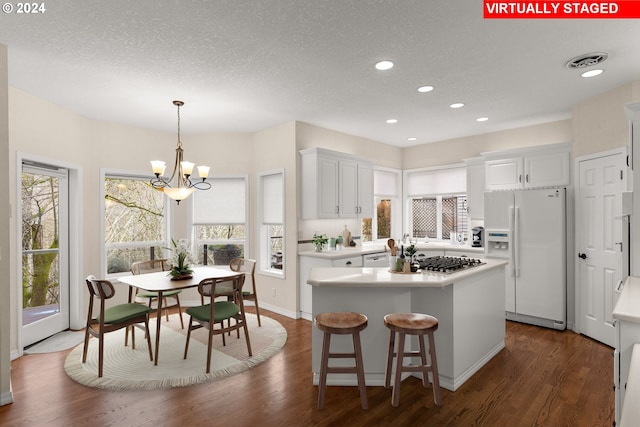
[{"left": 103, "top": 174, "right": 167, "bottom": 276}]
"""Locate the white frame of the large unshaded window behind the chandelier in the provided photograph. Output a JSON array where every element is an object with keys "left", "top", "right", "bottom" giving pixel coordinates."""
[{"left": 100, "top": 168, "right": 173, "bottom": 279}]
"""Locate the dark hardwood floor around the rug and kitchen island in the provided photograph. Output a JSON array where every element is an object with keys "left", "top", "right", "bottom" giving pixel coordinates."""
[{"left": 0, "top": 312, "right": 614, "bottom": 427}]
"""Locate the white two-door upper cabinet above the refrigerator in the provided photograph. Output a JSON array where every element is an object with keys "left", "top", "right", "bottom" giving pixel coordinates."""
[{"left": 485, "top": 151, "right": 571, "bottom": 191}]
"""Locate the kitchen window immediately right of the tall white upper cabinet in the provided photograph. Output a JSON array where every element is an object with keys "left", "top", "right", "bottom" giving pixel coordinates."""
[{"left": 361, "top": 168, "right": 402, "bottom": 242}]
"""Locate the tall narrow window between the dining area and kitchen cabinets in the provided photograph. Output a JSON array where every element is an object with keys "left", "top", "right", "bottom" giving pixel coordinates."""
[{"left": 258, "top": 171, "right": 285, "bottom": 275}]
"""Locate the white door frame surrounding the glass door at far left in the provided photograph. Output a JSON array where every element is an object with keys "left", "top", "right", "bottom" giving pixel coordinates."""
[{"left": 11, "top": 152, "right": 84, "bottom": 360}]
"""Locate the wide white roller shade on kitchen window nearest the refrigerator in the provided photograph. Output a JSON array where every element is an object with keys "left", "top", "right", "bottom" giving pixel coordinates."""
[{"left": 407, "top": 167, "right": 467, "bottom": 196}]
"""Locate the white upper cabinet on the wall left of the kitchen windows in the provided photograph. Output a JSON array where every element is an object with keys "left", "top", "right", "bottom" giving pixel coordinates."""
[{"left": 300, "top": 148, "right": 373, "bottom": 219}]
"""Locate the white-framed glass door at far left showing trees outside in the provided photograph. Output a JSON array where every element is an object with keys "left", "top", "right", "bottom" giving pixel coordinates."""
[{"left": 21, "top": 164, "right": 69, "bottom": 347}]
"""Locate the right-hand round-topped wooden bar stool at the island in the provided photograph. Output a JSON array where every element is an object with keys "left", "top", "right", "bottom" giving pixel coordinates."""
[{"left": 384, "top": 313, "right": 442, "bottom": 407}]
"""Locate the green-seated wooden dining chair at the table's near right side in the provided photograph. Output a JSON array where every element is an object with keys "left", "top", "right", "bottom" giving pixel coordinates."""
[{"left": 184, "top": 275, "right": 253, "bottom": 373}]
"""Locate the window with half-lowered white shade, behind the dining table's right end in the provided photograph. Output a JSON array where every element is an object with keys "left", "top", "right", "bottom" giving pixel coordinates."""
[{"left": 193, "top": 176, "right": 248, "bottom": 265}]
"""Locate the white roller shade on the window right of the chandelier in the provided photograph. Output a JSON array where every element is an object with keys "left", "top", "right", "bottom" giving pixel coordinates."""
[{"left": 193, "top": 178, "right": 247, "bottom": 225}]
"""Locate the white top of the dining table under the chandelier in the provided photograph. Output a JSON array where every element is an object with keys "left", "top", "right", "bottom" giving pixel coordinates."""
[{"left": 118, "top": 266, "right": 244, "bottom": 292}]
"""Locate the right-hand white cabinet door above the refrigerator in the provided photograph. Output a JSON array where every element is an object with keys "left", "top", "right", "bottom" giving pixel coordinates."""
[{"left": 524, "top": 153, "right": 569, "bottom": 188}]
